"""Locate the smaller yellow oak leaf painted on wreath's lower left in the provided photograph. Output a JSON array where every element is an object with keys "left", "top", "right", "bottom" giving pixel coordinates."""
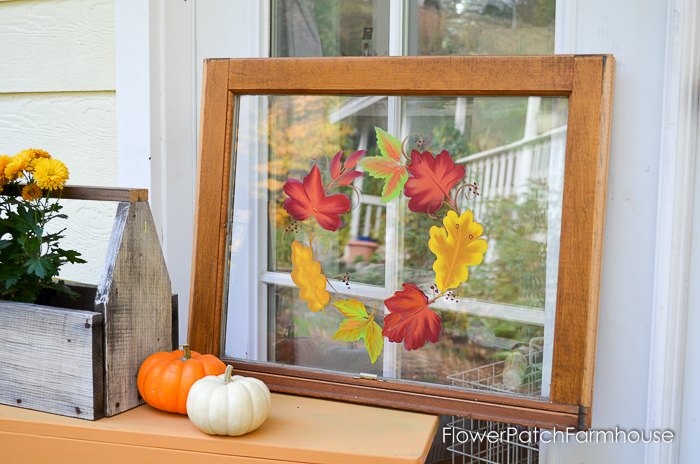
[{"left": 292, "top": 240, "right": 331, "bottom": 312}]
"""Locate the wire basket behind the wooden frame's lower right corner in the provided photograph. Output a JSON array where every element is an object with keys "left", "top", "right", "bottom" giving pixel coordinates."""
[{"left": 440, "top": 337, "right": 544, "bottom": 464}]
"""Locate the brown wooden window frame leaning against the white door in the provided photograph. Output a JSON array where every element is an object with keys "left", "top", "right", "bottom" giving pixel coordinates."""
[{"left": 188, "top": 55, "right": 615, "bottom": 429}]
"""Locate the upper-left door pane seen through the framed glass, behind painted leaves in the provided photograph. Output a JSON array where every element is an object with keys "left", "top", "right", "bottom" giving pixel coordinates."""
[{"left": 266, "top": 96, "right": 387, "bottom": 286}]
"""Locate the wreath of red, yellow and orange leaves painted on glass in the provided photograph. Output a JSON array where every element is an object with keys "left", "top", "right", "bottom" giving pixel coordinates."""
[{"left": 283, "top": 128, "right": 488, "bottom": 364}]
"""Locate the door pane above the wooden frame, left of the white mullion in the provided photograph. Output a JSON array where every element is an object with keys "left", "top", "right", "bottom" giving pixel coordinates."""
[{"left": 271, "top": 0, "right": 389, "bottom": 56}]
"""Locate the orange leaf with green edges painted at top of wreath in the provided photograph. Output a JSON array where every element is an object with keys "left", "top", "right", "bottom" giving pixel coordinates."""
[{"left": 360, "top": 127, "right": 408, "bottom": 202}]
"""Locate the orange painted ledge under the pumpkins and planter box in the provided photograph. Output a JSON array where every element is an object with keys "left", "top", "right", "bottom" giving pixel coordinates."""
[{"left": 0, "top": 394, "right": 438, "bottom": 464}]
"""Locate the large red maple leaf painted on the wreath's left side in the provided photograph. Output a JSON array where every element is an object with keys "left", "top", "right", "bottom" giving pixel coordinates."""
[{"left": 283, "top": 164, "right": 350, "bottom": 232}]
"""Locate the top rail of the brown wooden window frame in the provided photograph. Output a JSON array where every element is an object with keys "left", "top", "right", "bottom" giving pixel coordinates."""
[{"left": 229, "top": 55, "right": 573, "bottom": 96}]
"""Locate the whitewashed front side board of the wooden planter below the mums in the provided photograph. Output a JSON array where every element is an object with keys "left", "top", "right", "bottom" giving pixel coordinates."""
[{"left": 0, "top": 301, "right": 103, "bottom": 419}]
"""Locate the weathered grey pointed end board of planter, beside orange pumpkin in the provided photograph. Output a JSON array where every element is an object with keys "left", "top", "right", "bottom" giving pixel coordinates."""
[{"left": 95, "top": 202, "right": 172, "bottom": 416}]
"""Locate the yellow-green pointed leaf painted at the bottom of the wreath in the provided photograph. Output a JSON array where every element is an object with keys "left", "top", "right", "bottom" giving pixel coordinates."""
[{"left": 333, "top": 299, "right": 384, "bottom": 364}]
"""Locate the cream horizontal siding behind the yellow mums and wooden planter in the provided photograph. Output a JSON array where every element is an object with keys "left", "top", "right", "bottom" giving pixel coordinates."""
[{"left": 0, "top": 0, "right": 117, "bottom": 283}]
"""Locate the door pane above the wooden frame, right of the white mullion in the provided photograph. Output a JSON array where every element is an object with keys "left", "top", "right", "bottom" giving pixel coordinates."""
[{"left": 404, "top": 0, "right": 556, "bottom": 55}]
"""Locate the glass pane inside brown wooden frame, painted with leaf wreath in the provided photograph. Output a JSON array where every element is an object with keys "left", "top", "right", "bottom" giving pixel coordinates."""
[{"left": 226, "top": 95, "right": 567, "bottom": 397}]
